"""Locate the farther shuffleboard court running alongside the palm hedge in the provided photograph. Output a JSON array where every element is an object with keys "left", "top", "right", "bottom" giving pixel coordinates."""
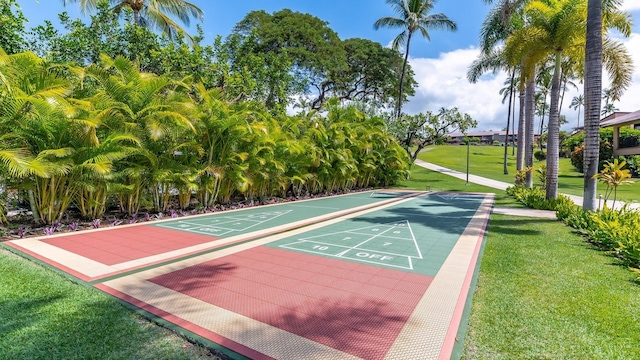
[{"left": 3, "top": 191, "right": 418, "bottom": 281}]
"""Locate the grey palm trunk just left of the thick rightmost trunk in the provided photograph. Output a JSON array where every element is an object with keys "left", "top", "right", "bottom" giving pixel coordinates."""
[{"left": 546, "top": 52, "right": 562, "bottom": 199}]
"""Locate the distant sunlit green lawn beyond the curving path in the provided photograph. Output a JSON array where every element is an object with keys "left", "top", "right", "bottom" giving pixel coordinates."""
[{"left": 418, "top": 145, "right": 640, "bottom": 201}]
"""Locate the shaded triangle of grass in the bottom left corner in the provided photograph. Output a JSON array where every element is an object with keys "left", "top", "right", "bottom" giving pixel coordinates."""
[{"left": 0, "top": 249, "right": 212, "bottom": 359}]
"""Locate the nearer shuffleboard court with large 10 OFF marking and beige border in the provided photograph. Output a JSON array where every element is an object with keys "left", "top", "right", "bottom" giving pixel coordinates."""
[{"left": 96, "top": 194, "right": 493, "bottom": 359}]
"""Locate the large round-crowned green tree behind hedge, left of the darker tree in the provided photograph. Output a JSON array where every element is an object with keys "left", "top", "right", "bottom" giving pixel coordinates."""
[{"left": 227, "top": 9, "right": 347, "bottom": 112}]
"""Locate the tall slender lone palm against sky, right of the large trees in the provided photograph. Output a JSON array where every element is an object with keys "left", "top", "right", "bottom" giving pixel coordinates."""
[{"left": 373, "top": 0, "right": 457, "bottom": 118}]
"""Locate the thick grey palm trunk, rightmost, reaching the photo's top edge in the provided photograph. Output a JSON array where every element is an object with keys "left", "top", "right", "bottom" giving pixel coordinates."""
[{"left": 582, "top": 0, "right": 602, "bottom": 211}]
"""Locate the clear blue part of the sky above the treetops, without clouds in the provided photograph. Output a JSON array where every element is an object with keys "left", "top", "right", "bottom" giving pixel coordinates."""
[{"left": 19, "top": 0, "right": 489, "bottom": 57}]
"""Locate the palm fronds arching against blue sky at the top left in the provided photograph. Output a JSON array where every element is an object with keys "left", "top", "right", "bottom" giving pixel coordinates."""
[{"left": 63, "top": 0, "right": 204, "bottom": 39}]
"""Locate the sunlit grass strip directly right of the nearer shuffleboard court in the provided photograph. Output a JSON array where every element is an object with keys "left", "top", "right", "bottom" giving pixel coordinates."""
[{"left": 463, "top": 215, "right": 640, "bottom": 359}]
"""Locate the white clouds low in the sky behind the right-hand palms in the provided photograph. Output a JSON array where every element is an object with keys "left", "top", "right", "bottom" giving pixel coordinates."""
[{"left": 403, "top": 30, "right": 640, "bottom": 130}]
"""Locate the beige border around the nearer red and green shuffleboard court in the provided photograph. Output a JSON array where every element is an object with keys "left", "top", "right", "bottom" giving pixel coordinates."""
[{"left": 99, "top": 195, "right": 493, "bottom": 360}]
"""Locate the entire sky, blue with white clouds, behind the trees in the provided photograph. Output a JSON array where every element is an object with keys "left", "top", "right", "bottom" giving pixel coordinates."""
[{"left": 13, "top": 0, "right": 640, "bottom": 131}]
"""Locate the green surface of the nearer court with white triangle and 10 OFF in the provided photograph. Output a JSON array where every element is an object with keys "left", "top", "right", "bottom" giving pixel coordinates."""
[{"left": 265, "top": 194, "right": 485, "bottom": 276}]
